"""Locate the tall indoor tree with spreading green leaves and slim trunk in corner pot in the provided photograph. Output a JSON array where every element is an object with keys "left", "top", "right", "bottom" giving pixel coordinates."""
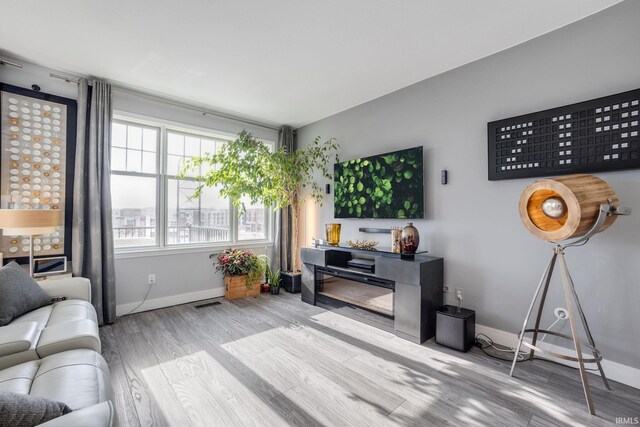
[{"left": 181, "top": 131, "right": 340, "bottom": 290}]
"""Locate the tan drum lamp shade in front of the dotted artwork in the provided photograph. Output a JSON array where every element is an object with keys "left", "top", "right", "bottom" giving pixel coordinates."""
[{"left": 0, "top": 209, "right": 62, "bottom": 236}]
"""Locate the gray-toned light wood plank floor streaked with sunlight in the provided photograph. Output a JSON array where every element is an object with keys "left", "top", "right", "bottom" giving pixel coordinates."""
[{"left": 100, "top": 293, "right": 640, "bottom": 427}]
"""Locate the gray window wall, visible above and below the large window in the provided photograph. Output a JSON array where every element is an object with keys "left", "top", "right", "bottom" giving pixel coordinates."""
[{"left": 0, "top": 56, "right": 278, "bottom": 314}]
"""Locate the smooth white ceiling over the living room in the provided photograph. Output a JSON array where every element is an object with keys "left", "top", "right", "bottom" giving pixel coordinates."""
[{"left": 0, "top": 0, "right": 620, "bottom": 127}]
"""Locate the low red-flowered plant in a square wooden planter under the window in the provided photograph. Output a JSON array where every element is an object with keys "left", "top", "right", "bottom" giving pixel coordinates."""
[{"left": 215, "top": 249, "right": 266, "bottom": 299}]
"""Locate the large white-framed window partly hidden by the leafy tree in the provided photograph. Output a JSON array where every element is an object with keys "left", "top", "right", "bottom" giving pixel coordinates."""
[{"left": 111, "top": 119, "right": 271, "bottom": 249}]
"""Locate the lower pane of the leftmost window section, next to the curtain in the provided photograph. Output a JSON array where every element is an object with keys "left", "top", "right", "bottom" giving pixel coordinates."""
[{"left": 111, "top": 175, "right": 157, "bottom": 248}]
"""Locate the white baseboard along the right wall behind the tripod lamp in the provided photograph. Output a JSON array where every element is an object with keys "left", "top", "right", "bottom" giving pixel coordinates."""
[{"left": 476, "top": 325, "right": 640, "bottom": 389}]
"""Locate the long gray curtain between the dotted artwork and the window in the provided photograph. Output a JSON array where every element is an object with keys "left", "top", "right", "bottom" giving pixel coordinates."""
[{"left": 71, "top": 79, "right": 116, "bottom": 325}]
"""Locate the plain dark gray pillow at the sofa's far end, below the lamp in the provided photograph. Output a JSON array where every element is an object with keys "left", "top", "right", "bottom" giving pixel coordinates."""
[{"left": 0, "top": 261, "right": 51, "bottom": 326}]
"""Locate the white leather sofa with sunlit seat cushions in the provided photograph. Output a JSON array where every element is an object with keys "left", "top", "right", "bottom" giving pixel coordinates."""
[{"left": 0, "top": 278, "right": 118, "bottom": 427}]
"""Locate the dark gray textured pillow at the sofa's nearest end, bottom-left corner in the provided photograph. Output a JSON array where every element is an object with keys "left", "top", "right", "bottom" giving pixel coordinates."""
[{"left": 0, "top": 391, "right": 71, "bottom": 427}]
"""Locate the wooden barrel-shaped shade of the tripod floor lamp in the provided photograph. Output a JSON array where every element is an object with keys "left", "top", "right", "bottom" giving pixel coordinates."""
[{"left": 519, "top": 174, "right": 620, "bottom": 242}]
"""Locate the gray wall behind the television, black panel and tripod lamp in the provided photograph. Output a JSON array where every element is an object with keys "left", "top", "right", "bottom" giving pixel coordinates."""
[{"left": 298, "top": 1, "right": 640, "bottom": 368}]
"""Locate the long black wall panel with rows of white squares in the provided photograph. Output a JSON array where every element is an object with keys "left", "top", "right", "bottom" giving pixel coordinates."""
[{"left": 487, "top": 89, "right": 640, "bottom": 181}]
